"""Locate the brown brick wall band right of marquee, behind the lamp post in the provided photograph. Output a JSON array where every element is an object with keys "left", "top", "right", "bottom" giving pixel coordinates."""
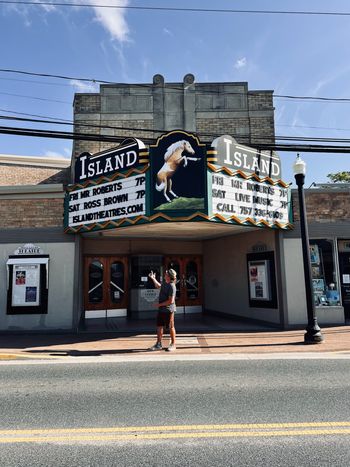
[{"left": 293, "top": 190, "right": 350, "bottom": 222}]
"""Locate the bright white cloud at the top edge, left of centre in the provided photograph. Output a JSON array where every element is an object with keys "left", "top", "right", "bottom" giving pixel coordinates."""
[{"left": 89, "top": 0, "right": 129, "bottom": 42}]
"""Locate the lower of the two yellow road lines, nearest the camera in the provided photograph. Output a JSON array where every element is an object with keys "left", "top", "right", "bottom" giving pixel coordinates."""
[{"left": 0, "top": 428, "right": 350, "bottom": 444}]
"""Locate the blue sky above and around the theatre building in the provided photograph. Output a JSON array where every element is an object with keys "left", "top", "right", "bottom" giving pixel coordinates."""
[{"left": 0, "top": 0, "right": 350, "bottom": 185}]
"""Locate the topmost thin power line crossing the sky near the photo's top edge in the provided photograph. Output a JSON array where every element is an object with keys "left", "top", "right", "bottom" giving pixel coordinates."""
[{"left": 0, "top": 0, "right": 350, "bottom": 16}]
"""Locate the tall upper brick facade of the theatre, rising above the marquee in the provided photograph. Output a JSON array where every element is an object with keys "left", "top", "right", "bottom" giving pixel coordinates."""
[{"left": 73, "top": 80, "right": 275, "bottom": 157}]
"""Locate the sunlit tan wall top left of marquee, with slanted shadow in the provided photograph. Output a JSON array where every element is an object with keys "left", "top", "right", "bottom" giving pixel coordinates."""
[{"left": 0, "top": 164, "right": 70, "bottom": 186}]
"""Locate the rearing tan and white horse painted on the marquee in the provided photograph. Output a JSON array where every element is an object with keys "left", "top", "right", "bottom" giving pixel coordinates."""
[{"left": 156, "top": 140, "right": 200, "bottom": 203}]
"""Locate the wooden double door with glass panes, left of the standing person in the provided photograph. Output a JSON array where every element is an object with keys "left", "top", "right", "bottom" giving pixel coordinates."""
[{"left": 84, "top": 256, "right": 129, "bottom": 310}]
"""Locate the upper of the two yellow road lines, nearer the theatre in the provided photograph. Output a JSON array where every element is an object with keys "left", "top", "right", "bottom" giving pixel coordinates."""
[{"left": 0, "top": 421, "right": 350, "bottom": 436}]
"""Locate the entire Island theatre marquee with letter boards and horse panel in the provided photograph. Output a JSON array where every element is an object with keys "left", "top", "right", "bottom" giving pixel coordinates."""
[{"left": 65, "top": 130, "right": 292, "bottom": 232}]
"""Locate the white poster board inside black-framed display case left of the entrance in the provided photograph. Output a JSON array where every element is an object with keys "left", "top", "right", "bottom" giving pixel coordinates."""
[{"left": 12, "top": 264, "right": 40, "bottom": 306}]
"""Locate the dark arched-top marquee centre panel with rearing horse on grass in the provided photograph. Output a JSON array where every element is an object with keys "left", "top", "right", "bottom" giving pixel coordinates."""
[{"left": 151, "top": 130, "right": 206, "bottom": 211}]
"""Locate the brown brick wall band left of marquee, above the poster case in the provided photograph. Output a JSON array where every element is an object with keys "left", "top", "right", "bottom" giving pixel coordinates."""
[{"left": 0, "top": 198, "right": 64, "bottom": 229}]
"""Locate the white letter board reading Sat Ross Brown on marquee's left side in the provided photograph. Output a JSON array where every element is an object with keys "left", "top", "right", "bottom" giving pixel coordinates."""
[{"left": 68, "top": 175, "right": 146, "bottom": 227}]
